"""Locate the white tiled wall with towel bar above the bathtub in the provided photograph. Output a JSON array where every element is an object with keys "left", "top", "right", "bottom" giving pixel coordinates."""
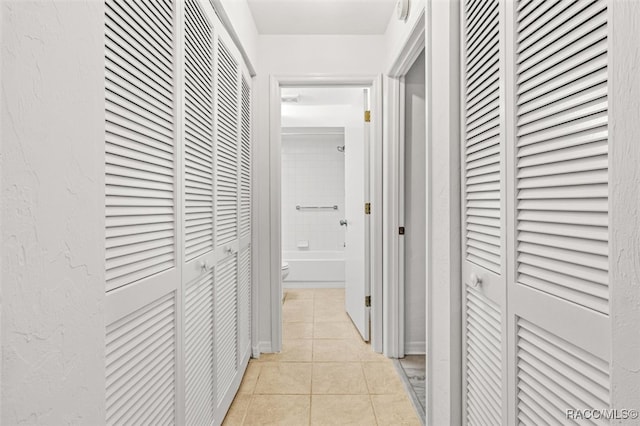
[{"left": 282, "top": 132, "right": 345, "bottom": 253}]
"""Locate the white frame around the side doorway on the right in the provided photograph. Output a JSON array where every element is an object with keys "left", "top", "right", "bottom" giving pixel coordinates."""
[{"left": 385, "top": 0, "right": 462, "bottom": 425}]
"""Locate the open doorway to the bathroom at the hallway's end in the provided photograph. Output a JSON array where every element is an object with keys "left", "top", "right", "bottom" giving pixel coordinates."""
[{"left": 270, "top": 76, "right": 382, "bottom": 359}]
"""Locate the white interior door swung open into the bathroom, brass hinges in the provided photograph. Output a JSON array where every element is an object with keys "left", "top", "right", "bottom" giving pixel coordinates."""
[{"left": 344, "top": 91, "right": 371, "bottom": 341}]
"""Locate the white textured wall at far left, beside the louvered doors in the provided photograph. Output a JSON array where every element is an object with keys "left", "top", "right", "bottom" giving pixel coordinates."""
[{"left": 1, "top": 0, "right": 105, "bottom": 425}]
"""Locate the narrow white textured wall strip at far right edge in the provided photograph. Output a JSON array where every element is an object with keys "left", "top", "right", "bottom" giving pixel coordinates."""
[{"left": 608, "top": 0, "right": 640, "bottom": 414}]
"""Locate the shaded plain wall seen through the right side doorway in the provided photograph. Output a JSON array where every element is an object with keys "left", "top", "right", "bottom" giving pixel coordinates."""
[{"left": 404, "top": 53, "right": 427, "bottom": 354}]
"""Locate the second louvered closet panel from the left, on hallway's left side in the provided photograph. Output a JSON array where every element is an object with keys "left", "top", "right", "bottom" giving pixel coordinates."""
[{"left": 182, "top": 0, "right": 216, "bottom": 425}]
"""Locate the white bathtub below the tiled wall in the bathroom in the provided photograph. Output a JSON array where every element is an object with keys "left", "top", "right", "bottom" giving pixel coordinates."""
[{"left": 282, "top": 251, "right": 344, "bottom": 288}]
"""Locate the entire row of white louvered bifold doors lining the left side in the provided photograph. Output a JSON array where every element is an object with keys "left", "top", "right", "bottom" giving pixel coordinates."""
[{"left": 105, "top": 0, "right": 251, "bottom": 425}]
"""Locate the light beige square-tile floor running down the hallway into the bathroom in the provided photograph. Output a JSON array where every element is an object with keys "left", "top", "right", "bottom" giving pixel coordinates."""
[{"left": 223, "top": 289, "right": 420, "bottom": 426}]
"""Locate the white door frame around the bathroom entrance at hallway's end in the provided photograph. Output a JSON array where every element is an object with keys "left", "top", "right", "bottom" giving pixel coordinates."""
[{"left": 269, "top": 74, "right": 385, "bottom": 352}]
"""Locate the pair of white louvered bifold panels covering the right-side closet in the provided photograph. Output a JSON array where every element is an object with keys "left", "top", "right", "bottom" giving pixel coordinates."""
[{"left": 462, "top": 0, "right": 614, "bottom": 425}]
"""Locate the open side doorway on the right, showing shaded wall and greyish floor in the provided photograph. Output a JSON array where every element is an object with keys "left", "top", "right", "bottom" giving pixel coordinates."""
[{"left": 399, "top": 50, "right": 428, "bottom": 421}]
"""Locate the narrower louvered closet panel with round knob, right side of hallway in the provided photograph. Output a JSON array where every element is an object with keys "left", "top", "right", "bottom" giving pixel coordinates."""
[{"left": 461, "top": 0, "right": 507, "bottom": 426}]
